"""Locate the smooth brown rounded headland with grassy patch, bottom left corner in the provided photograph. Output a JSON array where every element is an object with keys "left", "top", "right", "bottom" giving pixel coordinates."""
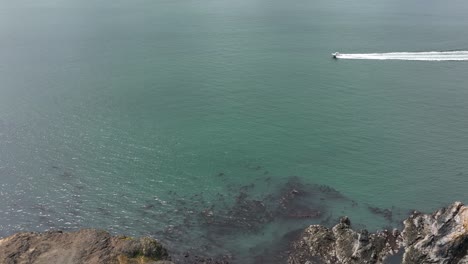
[{"left": 0, "top": 229, "right": 172, "bottom": 264}]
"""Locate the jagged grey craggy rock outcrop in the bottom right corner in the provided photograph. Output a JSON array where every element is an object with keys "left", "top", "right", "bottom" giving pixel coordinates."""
[{"left": 288, "top": 202, "right": 468, "bottom": 264}]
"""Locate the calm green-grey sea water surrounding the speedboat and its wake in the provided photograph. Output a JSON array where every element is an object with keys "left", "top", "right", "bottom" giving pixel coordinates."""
[{"left": 0, "top": 0, "right": 468, "bottom": 263}]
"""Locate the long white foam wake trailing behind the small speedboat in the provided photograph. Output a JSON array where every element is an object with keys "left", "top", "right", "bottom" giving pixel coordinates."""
[{"left": 336, "top": 51, "right": 468, "bottom": 61}]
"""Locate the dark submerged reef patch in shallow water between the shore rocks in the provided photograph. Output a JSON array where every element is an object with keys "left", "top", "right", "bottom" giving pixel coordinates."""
[{"left": 145, "top": 174, "right": 401, "bottom": 263}]
